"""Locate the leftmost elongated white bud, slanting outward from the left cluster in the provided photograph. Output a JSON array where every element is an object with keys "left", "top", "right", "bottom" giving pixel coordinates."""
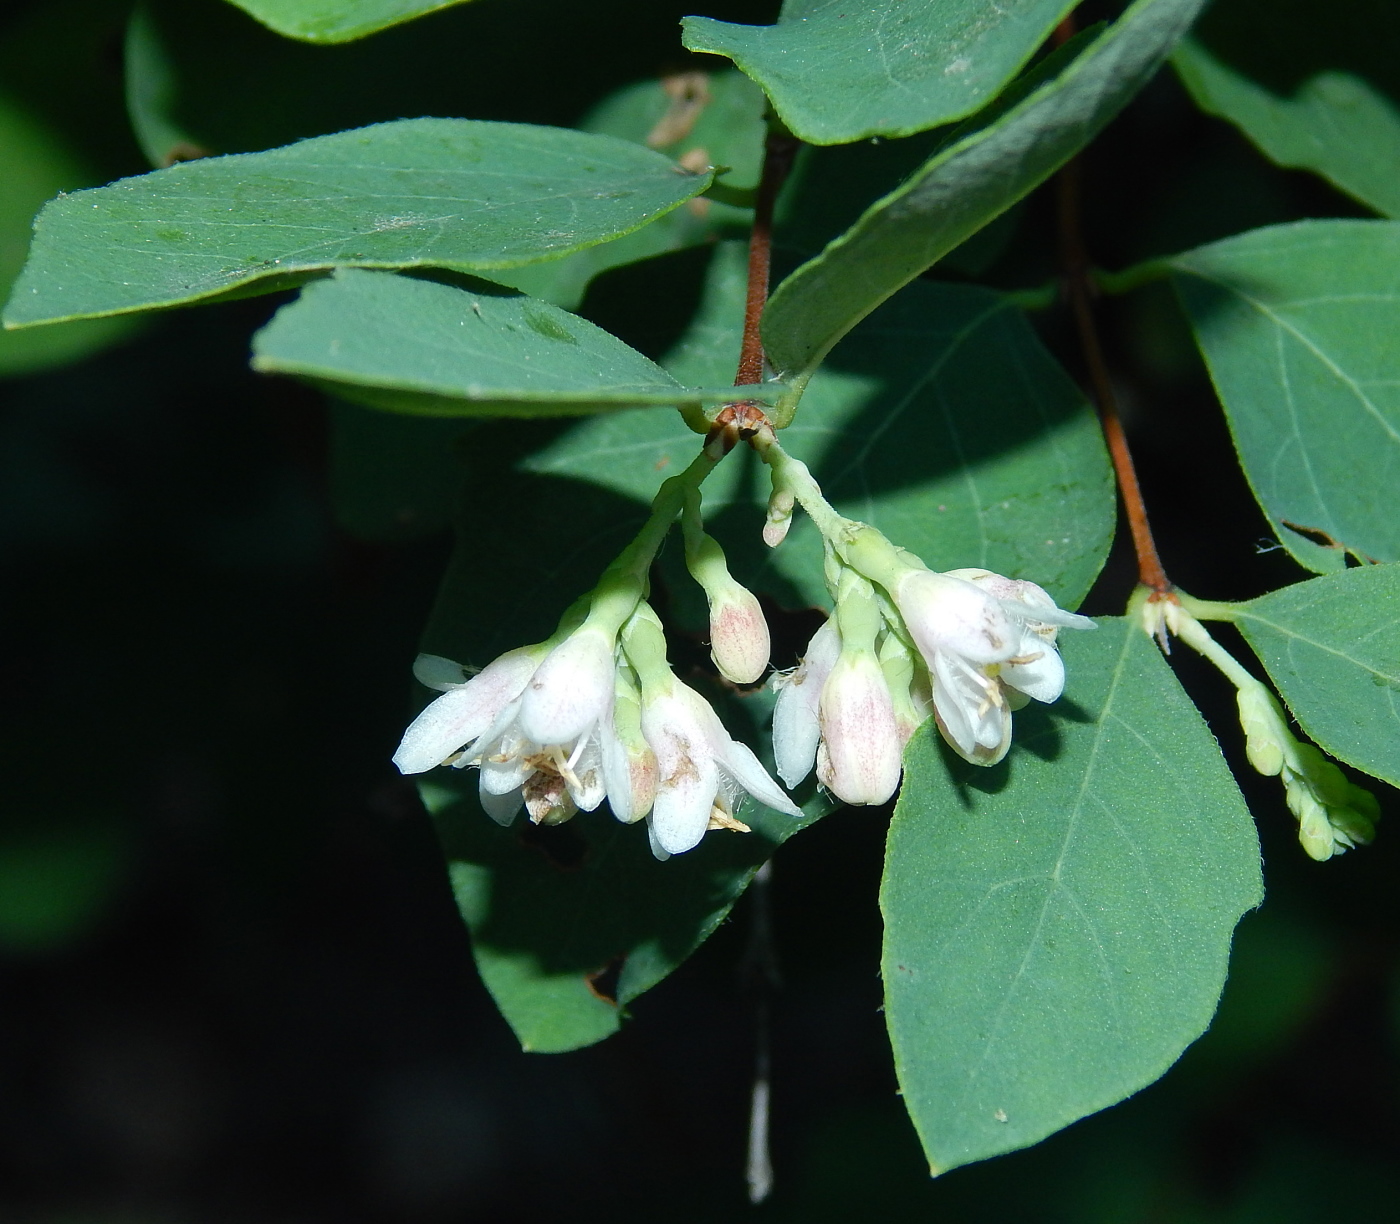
[{"left": 393, "top": 646, "right": 545, "bottom": 773}]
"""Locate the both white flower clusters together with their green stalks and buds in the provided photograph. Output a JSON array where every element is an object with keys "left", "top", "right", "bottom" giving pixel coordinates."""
[{"left": 393, "top": 436, "right": 1093, "bottom": 858}]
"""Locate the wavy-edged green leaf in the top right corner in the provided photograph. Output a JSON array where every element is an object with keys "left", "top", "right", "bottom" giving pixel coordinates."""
[{"left": 1172, "top": 39, "right": 1400, "bottom": 217}]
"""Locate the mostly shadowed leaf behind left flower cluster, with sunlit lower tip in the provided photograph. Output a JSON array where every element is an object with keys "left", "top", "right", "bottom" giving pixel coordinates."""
[{"left": 420, "top": 431, "right": 830, "bottom": 1052}]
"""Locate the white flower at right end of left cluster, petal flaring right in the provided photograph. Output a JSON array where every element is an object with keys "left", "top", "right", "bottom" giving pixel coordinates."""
[{"left": 641, "top": 675, "right": 802, "bottom": 858}]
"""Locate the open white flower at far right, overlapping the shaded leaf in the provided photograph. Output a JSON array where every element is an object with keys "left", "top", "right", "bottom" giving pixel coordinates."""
[{"left": 892, "top": 569, "right": 1093, "bottom": 765}]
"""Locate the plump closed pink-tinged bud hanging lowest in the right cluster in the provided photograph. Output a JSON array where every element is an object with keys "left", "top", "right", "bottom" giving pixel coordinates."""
[{"left": 818, "top": 650, "right": 903, "bottom": 804}]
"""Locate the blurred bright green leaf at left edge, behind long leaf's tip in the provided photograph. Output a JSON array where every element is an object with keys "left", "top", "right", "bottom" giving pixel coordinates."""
[{"left": 0, "top": 95, "right": 132, "bottom": 377}]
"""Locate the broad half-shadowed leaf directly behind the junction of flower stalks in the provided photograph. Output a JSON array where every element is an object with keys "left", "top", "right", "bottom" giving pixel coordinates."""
[{"left": 551, "top": 245, "right": 1116, "bottom": 606}]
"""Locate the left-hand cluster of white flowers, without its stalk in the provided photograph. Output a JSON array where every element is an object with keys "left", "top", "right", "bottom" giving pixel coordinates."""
[{"left": 393, "top": 602, "right": 801, "bottom": 858}]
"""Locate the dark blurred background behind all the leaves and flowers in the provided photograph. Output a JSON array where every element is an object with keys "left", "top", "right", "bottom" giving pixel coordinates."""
[{"left": 0, "top": 0, "right": 1400, "bottom": 1224}]
